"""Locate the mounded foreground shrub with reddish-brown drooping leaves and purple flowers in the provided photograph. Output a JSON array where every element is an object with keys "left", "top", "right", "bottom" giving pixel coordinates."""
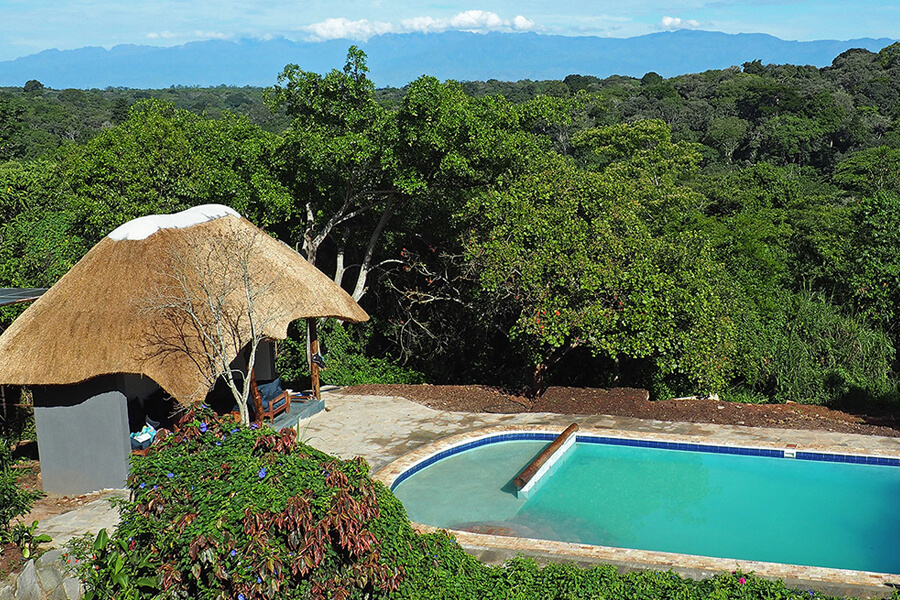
[{"left": 72, "top": 409, "right": 409, "bottom": 600}]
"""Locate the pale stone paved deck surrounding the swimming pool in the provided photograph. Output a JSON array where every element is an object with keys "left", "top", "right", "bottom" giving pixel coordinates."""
[{"left": 299, "top": 391, "right": 900, "bottom": 597}]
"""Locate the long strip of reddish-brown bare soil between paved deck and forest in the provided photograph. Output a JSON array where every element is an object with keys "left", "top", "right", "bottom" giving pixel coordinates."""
[{"left": 341, "top": 385, "right": 900, "bottom": 437}]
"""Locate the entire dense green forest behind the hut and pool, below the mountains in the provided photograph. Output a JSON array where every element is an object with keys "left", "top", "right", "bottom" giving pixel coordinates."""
[{"left": 0, "top": 44, "right": 900, "bottom": 404}]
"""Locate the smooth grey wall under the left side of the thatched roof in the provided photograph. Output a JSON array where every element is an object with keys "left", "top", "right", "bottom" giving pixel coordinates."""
[{"left": 33, "top": 376, "right": 131, "bottom": 495}]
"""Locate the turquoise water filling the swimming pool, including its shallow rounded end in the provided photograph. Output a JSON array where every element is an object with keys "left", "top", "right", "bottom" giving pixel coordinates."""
[{"left": 394, "top": 441, "right": 900, "bottom": 573}]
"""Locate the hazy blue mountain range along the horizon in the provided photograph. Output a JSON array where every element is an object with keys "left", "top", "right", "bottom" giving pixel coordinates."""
[{"left": 0, "top": 30, "right": 896, "bottom": 89}]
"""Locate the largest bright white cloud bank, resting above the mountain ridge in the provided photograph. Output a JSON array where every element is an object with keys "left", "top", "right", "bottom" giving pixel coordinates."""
[{"left": 303, "top": 10, "right": 535, "bottom": 41}]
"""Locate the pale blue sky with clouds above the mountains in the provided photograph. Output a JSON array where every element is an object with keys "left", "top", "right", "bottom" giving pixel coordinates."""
[{"left": 0, "top": 0, "right": 900, "bottom": 60}]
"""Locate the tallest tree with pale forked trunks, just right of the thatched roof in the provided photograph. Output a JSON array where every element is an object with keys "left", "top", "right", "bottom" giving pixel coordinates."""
[{"left": 269, "top": 47, "right": 534, "bottom": 299}]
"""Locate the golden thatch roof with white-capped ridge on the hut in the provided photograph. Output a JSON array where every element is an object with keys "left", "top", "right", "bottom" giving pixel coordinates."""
[{"left": 0, "top": 205, "right": 369, "bottom": 401}]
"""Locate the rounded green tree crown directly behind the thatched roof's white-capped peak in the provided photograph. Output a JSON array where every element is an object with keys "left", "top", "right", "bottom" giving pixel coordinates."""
[{"left": 60, "top": 100, "right": 290, "bottom": 242}]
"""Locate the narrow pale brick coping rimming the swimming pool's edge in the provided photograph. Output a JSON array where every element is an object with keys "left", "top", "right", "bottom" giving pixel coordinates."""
[{"left": 373, "top": 425, "right": 900, "bottom": 588}]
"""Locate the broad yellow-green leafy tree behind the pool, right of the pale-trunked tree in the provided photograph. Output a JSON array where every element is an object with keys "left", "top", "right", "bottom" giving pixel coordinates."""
[{"left": 467, "top": 150, "right": 733, "bottom": 393}]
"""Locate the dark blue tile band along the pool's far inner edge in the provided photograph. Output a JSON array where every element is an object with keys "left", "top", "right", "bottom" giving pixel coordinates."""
[{"left": 391, "top": 432, "right": 900, "bottom": 490}]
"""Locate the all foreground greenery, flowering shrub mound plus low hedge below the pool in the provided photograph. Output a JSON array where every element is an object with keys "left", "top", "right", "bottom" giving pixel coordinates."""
[{"left": 68, "top": 409, "right": 856, "bottom": 600}]
